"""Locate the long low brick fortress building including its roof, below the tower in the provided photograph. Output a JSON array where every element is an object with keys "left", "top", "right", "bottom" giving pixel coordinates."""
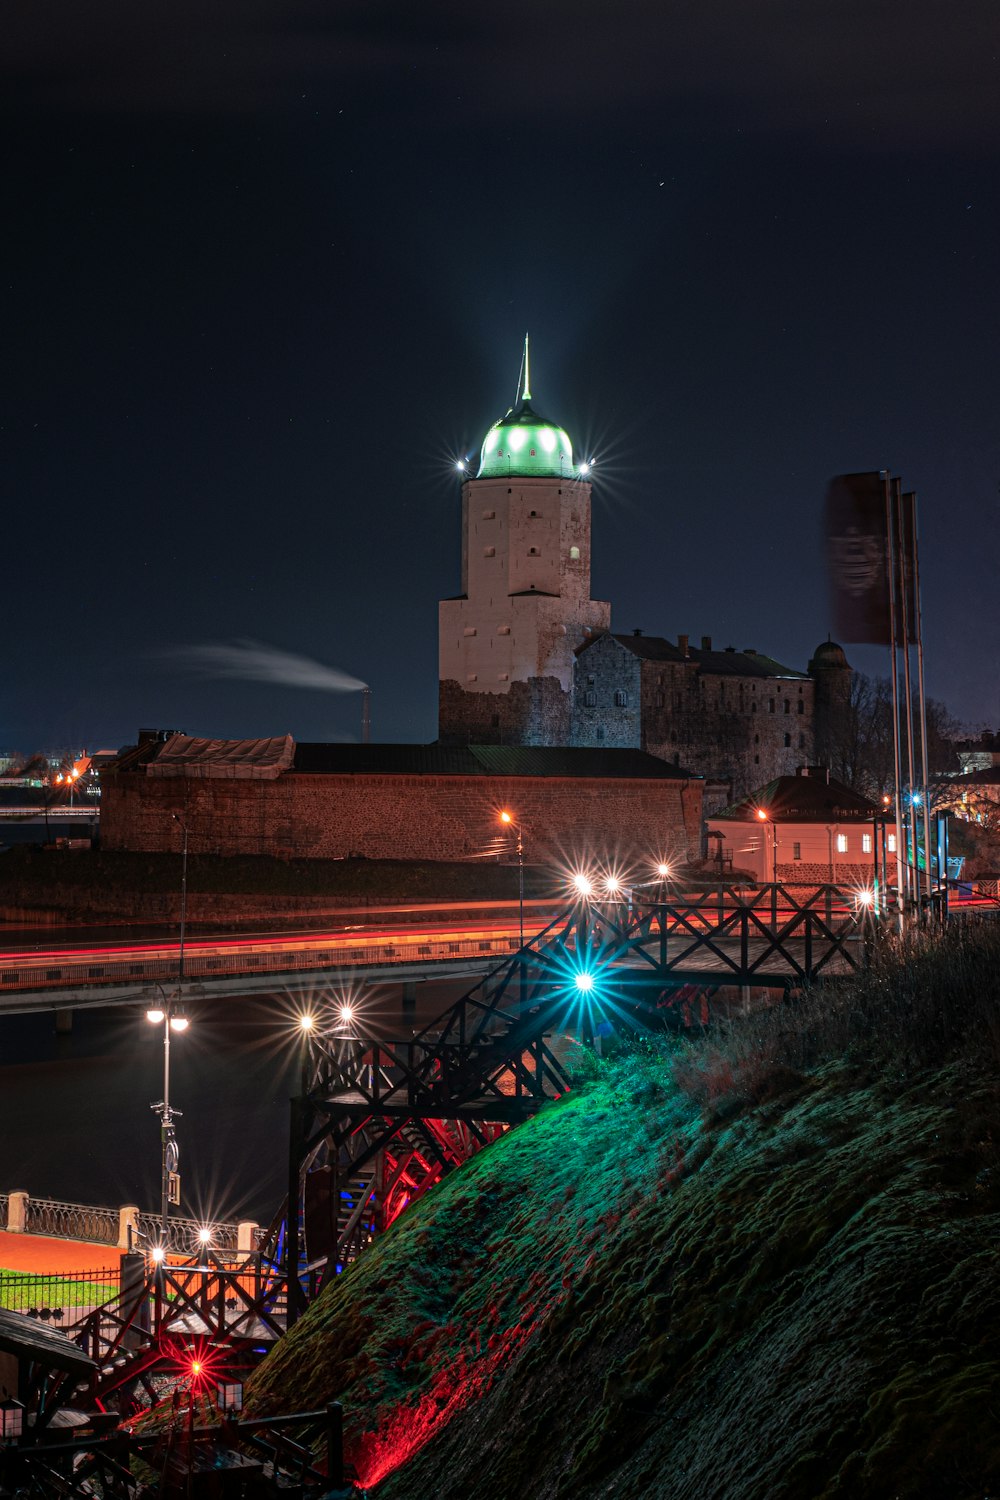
[{"left": 100, "top": 732, "right": 702, "bottom": 867}]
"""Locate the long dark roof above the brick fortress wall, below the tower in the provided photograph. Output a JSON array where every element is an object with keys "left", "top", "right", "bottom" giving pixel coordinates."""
[{"left": 292, "top": 743, "right": 691, "bottom": 782}]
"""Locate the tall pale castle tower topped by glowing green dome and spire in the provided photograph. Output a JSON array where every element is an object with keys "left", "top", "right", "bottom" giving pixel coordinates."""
[{"left": 438, "top": 348, "right": 610, "bottom": 746}]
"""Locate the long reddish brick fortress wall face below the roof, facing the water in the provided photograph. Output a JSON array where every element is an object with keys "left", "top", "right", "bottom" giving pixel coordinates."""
[{"left": 100, "top": 771, "right": 702, "bottom": 864}]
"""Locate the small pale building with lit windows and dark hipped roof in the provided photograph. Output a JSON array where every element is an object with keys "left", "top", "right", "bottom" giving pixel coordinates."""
[{"left": 706, "top": 767, "right": 897, "bottom": 887}]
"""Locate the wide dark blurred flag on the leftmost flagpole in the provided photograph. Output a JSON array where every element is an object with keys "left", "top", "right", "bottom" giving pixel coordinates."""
[{"left": 826, "top": 470, "right": 892, "bottom": 645}]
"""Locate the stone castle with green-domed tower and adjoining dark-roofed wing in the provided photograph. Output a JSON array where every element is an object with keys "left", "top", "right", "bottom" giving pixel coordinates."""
[{"left": 438, "top": 345, "right": 850, "bottom": 801}]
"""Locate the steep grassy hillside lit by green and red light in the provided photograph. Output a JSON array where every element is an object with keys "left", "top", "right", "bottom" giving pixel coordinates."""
[{"left": 249, "top": 926, "right": 1000, "bottom": 1500}]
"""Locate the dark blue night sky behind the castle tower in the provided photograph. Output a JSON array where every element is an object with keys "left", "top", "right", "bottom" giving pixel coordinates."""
[{"left": 0, "top": 0, "right": 1000, "bottom": 750}]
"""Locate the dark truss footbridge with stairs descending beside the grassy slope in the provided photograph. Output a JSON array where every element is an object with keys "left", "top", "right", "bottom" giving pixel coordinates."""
[{"left": 283, "top": 885, "right": 874, "bottom": 1319}]
